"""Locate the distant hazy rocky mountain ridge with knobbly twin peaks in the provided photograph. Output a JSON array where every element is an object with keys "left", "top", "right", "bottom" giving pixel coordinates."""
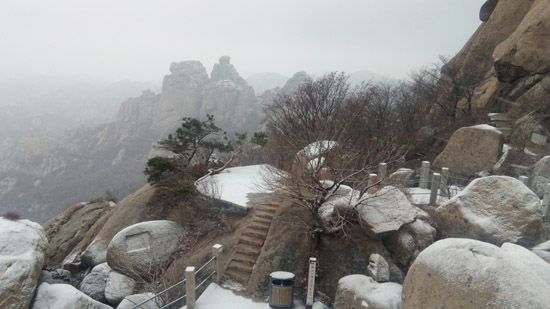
[{"left": 0, "top": 56, "right": 266, "bottom": 221}]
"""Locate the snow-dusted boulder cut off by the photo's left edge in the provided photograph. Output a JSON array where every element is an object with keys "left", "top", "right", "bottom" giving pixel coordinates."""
[{"left": 0, "top": 217, "right": 48, "bottom": 309}]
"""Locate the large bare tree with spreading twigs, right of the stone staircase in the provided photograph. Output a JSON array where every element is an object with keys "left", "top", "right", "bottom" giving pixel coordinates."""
[{"left": 266, "top": 73, "right": 400, "bottom": 233}]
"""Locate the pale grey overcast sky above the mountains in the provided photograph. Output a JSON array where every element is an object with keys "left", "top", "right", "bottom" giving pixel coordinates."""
[{"left": 0, "top": 0, "right": 484, "bottom": 83}]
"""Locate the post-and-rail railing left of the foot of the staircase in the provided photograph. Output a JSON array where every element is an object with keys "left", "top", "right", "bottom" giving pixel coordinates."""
[{"left": 132, "top": 244, "right": 223, "bottom": 309}]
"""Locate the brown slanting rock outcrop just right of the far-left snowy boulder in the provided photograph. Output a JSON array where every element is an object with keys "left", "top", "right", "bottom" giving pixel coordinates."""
[{"left": 44, "top": 202, "right": 111, "bottom": 265}]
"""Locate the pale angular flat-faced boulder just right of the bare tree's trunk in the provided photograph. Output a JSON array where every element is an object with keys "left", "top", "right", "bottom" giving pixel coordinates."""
[{"left": 357, "top": 186, "right": 419, "bottom": 234}]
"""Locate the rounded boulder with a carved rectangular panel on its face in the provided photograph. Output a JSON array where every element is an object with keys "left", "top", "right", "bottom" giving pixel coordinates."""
[{"left": 107, "top": 220, "right": 186, "bottom": 279}]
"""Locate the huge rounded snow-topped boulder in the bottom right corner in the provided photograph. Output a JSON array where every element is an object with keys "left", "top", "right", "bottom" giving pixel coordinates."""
[{"left": 403, "top": 238, "right": 550, "bottom": 309}]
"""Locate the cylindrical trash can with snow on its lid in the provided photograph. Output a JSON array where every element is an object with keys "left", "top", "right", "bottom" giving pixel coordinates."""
[{"left": 269, "top": 271, "right": 296, "bottom": 308}]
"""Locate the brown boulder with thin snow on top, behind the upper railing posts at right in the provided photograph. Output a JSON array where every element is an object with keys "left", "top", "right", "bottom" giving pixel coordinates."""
[{"left": 434, "top": 124, "right": 502, "bottom": 176}]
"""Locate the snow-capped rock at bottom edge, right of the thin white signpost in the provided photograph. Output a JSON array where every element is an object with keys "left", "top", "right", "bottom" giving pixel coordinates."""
[{"left": 334, "top": 275, "right": 402, "bottom": 309}]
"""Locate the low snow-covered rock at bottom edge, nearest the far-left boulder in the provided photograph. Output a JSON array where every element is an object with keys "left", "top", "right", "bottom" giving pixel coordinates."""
[{"left": 31, "top": 282, "right": 112, "bottom": 309}]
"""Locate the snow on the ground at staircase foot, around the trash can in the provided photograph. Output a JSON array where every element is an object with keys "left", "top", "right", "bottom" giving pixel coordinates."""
[{"left": 193, "top": 283, "right": 328, "bottom": 309}]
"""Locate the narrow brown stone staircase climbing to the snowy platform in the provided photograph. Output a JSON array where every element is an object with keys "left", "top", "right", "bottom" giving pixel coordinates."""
[{"left": 225, "top": 199, "right": 279, "bottom": 287}]
